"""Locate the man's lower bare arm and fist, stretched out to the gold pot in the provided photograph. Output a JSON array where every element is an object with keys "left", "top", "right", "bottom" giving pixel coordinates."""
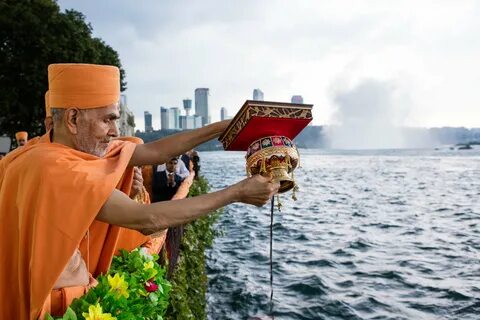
[{"left": 97, "top": 175, "right": 280, "bottom": 235}]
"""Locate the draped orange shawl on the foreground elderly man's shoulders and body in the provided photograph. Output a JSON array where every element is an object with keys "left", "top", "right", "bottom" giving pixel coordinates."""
[{"left": 0, "top": 133, "right": 135, "bottom": 319}]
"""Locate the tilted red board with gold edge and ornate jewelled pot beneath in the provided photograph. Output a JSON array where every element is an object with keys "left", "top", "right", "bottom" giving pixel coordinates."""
[{"left": 219, "top": 100, "right": 313, "bottom": 192}]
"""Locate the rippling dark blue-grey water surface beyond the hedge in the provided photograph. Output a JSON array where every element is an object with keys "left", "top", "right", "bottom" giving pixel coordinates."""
[{"left": 201, "top": 150, "right": 480, "bottom": 319}]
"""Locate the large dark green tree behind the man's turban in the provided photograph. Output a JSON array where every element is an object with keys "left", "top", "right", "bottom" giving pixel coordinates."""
[{"left": 0, "top": 0, "right": 126, "bottom": 145}]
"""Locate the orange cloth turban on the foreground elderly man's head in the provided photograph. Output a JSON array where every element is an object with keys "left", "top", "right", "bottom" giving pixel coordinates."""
[{"left": 48, "top": 63, "right": 120, "bottom": 109}]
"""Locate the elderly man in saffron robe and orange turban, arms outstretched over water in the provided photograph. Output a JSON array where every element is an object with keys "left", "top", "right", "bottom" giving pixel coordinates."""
[{"left": 0, "top": 64, "right": 279, "bottom": 319}]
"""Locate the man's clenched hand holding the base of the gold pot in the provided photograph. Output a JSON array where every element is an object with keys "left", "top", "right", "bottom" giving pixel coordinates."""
[{"left": 234, "top": 175, "right": 280, "bottom": 207}]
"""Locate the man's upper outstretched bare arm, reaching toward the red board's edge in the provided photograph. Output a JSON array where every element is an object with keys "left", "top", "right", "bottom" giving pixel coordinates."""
[{"left": 129, "top": 120, "right": 231, "bottom": 166}]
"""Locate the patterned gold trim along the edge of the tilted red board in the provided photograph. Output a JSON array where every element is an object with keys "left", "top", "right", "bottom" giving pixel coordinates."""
[{"left": 219, "top": 100, "right": 313, "bottom": 149}]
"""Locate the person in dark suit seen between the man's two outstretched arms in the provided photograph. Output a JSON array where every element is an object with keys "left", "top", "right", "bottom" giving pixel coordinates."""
[{"left": 152, "top": 158, "right": 183, "bottom": 202}]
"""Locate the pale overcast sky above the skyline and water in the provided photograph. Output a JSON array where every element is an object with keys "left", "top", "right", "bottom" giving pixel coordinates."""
[{"left": 58, "top": 0, "right": 480, "bottom": 130}]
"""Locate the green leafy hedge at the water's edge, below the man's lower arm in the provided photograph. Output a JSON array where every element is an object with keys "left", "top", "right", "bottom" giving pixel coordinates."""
[{"left": 166, "top": 177, "right": 220, "bottom": 320}]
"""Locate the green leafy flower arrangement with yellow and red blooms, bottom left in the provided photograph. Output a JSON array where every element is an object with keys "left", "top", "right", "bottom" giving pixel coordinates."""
[{"left": 45, "top": 248, "right": 171, "bottom": 320}]
